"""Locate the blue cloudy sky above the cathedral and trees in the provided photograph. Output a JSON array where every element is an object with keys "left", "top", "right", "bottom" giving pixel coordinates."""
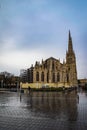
[{"left": 0, "top": 0, "right": 87, "bottom": 78}]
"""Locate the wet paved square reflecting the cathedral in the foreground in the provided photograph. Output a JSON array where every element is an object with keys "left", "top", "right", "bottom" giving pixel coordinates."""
[{"left": 0, "top": 91, "right": 87, "bottom": 130}]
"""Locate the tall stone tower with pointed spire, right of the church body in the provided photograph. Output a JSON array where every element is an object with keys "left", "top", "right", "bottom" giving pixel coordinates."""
[{"left": 66, "top": 31, "right": 78, "bottom": 86}]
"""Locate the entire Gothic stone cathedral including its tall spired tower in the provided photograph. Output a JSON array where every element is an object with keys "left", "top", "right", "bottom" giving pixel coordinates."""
[{"left": 21, "top": 31, "right": 78, "bottom": 87}]
